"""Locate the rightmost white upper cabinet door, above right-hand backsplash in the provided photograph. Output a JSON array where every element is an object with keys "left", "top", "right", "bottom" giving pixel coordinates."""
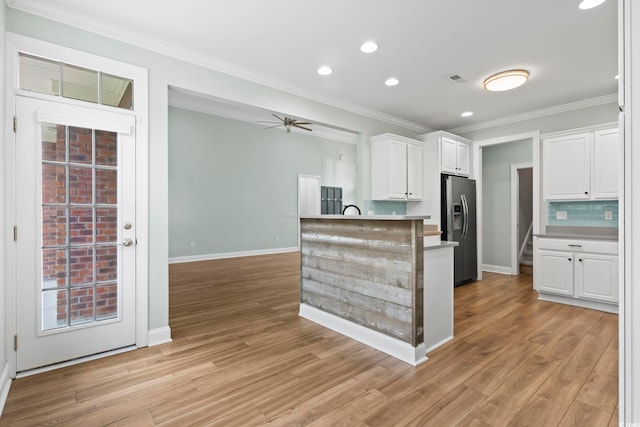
[{"left": 592, "top": 129, "right": 620, "bottom": 199}]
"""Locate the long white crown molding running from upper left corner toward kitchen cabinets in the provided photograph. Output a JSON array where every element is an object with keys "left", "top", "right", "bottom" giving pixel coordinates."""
[{"left": 6, "top": 0, "right": 431, "bottom": 132}]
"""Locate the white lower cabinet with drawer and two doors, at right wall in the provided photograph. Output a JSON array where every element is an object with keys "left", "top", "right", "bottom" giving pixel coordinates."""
[{"left": 534, "top": 237, "right": 618, "bottom": 312}]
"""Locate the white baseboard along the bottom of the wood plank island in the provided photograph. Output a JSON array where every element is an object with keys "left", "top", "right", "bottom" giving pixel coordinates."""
[{"left": 299, "top": 304, "right": 427, "bottom": 366}]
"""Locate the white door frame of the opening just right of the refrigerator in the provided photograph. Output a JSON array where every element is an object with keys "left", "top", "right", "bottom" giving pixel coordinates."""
[{"left": 471, "top": 131, "right": 540, "bottom": 280}]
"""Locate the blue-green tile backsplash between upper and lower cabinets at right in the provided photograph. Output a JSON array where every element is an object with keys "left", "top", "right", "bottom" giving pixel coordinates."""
[{"left": 547, "top": 200, "right": 618, "bottom": 227}]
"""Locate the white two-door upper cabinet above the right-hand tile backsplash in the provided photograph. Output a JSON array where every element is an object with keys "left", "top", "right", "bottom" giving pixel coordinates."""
[{"left": 542, "top": 129, "right": 620, "bottom": 200}]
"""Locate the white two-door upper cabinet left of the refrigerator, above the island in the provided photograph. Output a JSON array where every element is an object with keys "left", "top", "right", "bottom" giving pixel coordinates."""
[{"left": 370, "top": 133, "right": 422, "bottom": 200}]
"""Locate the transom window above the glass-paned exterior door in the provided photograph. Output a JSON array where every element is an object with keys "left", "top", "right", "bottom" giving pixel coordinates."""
[{"left": 19, "top": 52, "right": 133, "bottom": 110}]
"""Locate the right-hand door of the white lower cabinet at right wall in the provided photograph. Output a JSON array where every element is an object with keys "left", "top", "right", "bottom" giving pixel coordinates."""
[{"left": 575, "top": 254, "right": 618, "bottom": 303}]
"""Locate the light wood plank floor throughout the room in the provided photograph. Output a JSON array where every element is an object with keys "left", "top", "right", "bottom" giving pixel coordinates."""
[{"left": 0, "top": 254, "right": 618, "bottom": 427}]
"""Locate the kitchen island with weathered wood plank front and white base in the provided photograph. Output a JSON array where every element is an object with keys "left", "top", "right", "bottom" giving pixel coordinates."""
[{"left": 300, "top": 215, "right": 453, "bottom": 365}]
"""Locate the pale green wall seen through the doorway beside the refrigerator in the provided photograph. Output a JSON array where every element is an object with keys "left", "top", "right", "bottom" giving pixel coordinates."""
[{"left": 482, "top": 139, "right": 533, "bottom": 268}]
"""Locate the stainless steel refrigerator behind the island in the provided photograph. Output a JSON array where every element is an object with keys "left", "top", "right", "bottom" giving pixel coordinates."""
[{"left": 441, "top": 175, "right": 478, "bottom": 286}]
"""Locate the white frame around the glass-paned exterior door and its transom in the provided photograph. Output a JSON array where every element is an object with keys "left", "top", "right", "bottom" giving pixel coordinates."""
[{"left": 0, "top": 32, "right": 149, "bottom": 378}]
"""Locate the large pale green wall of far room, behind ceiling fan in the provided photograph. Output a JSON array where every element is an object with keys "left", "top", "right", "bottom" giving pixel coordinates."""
[{"left": 169, "top": 107, "right": 356, "bottom": 258}]
